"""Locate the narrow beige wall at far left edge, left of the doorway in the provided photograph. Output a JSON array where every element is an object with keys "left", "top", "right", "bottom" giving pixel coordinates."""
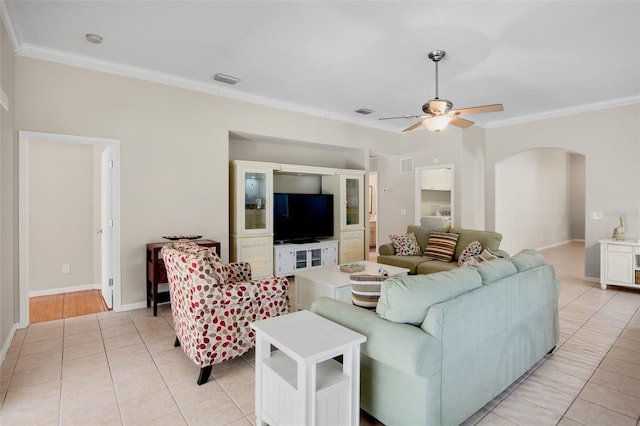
[{"left": 0, "top": 15, "right": 20, "bottom": 356}]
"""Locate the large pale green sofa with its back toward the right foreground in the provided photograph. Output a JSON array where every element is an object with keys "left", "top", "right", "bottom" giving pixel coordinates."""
[{"left": 311, "top": 250, "right": 560, "bottom": 426}]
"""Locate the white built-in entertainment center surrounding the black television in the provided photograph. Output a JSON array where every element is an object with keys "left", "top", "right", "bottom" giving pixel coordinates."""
[{"left": 229, "top": 160, "right": 365, "bottom": 277}]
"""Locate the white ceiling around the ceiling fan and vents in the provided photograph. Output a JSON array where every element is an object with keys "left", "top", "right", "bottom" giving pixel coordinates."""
[{"left": 0, "top": 0, "right": 640, "bottom": 130}]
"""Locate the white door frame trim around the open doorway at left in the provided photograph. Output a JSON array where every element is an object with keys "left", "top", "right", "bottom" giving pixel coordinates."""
[{"left": 18, "top": 131, "right": 121, "bottom": 328}]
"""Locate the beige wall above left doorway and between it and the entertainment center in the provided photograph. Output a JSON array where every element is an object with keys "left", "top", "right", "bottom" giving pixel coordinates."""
[{"left": 16, "top": 57, "right": 399, "bottom": 309}]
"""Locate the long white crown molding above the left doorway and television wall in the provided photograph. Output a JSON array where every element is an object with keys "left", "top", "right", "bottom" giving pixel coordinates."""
[{"left": 16, "top": 43, "right": 399, "bottom": 133}]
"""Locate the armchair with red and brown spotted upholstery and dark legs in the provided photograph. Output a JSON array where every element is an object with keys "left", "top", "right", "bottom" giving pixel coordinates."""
[{"left": 162, "top": 241, "right": 289, "bottom": 385}]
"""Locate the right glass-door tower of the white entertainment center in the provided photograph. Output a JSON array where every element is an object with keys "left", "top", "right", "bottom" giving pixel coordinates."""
[{"left": 322, "top": 170, "right": 365, "bottom": 264}]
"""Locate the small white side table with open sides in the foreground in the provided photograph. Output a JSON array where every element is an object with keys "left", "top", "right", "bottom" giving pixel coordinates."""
[{"left": 251, "top": 311, "right": 367, "bottom": 426}]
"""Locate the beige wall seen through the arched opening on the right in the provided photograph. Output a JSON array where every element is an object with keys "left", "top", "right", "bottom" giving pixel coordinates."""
[{"left": 495, "top": 148, "right": 586, "bottom": 254}]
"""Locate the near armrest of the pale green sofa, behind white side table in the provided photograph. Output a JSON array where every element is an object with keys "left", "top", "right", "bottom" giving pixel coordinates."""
[{"left": 311, "top": 297, "right": 442, "bottom": 377}]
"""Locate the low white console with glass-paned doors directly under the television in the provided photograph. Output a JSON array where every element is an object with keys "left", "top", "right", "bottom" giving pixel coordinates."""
[{"left": 273, "top": 240, "right": 338, "bottom": 276}]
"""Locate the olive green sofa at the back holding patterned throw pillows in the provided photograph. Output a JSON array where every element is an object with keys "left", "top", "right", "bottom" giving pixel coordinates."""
[{"left": 378, "top": 225, "right": 509, "bottom": 275}]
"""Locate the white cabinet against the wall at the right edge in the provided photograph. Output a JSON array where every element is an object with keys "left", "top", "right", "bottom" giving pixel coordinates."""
[{"left": 600, "top": 239, "right": 640, "bottom": 289}]
